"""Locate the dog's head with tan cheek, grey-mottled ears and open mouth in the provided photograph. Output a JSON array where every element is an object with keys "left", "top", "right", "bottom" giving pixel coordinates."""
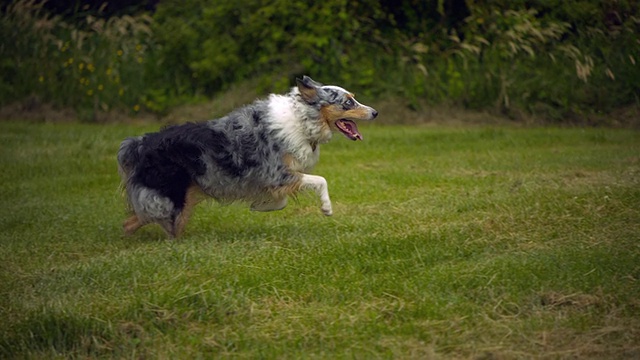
[{"left": 296, "top": 76, "right": 378, "bottom": 140}]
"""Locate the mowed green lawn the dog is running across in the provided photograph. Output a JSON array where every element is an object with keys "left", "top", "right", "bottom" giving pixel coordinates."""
[{"left": 0, "top": 123, "right": 640, "bottom": 359}]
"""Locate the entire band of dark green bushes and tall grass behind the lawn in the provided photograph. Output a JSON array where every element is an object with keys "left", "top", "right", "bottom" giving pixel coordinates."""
[{"left": 0, "top": 0, "right": 640, "bottom": 120}]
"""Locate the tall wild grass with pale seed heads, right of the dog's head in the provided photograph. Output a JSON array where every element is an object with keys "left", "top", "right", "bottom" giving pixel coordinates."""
[{"left": 390, "top": 2, "right": 640, "bottom": 122}]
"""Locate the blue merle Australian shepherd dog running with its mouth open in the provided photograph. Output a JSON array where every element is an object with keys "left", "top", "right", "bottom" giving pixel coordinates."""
[{"left": 118, "top": 76, "right": 378, "bottom": 238}]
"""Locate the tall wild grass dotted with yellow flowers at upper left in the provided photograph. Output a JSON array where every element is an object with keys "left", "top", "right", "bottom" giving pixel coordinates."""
[{"left": 0, "top": 0, "right": 153, "bottom": 119}]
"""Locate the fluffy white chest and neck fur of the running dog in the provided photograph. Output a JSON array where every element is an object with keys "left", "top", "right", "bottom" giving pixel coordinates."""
[{"left": 269, "top": 95, "right": 331, "bottom": 172}]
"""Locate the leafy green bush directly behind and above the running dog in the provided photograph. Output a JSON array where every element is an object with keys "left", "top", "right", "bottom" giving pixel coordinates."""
[{"left": 154, "top": 0, "right": 393, "bottom": 93}]
